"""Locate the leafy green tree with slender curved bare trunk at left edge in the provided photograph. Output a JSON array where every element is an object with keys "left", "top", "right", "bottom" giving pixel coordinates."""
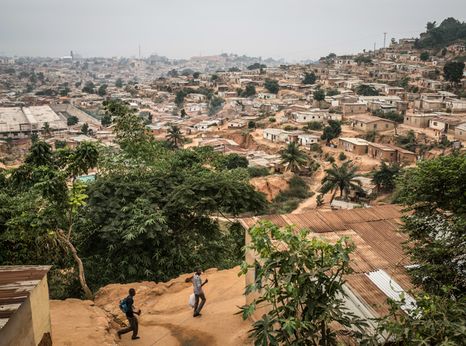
[{"left": 0, "top": 142, "right": 97, "bottom": 298}]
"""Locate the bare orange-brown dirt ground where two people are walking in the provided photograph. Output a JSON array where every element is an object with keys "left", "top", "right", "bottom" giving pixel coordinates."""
[{"left": 51, "top": 267, "right": 251, "bottom": 346}]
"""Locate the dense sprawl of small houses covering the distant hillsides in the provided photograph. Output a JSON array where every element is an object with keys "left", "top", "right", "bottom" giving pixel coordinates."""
[{"left": 0, "top": 39, "right": 466, "bottom": 177}]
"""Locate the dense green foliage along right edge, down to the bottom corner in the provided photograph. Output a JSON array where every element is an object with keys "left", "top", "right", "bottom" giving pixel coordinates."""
[{"left": 370, "top": 154, "right": 466, "bottom": 345}]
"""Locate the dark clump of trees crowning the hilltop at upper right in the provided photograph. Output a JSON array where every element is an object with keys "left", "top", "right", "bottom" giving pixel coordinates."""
[{"left": 415, "top": 17, "right": 466, "bottom": 49}]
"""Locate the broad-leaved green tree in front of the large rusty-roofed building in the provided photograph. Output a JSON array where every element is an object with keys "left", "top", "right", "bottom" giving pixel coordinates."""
[{"left": 240, "top": 222, "right": 366, "bottom": 346}]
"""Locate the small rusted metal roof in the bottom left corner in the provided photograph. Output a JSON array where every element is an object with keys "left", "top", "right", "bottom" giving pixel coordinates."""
[{"left": 0, "top": 266, "right": 51, "bottom": 329}]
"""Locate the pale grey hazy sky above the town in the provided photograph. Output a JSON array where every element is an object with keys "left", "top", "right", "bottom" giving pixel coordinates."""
[{"left": 0, "top": 0, "right": 466, "bottom": 61}]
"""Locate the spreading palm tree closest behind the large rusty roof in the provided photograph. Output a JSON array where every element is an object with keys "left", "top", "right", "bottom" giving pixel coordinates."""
[{"left": 320, "top": 161, "right": 364, "bottom": 203}]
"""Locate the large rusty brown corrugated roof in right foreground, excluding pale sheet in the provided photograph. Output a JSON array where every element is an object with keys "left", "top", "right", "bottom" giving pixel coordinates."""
[{"left": 240, "top": 205, "right": 413, "bottom": 316}]
